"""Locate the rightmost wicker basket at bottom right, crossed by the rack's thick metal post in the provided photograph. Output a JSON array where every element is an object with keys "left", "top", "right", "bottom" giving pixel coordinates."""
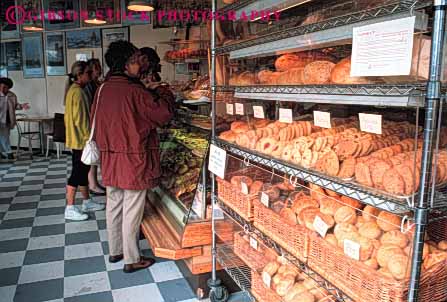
[{"left": 307, "top": 234, "right": 447, "bottom": 302}]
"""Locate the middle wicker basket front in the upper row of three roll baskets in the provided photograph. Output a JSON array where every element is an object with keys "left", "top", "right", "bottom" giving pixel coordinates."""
[{"left": 254, "top": 199, "right": 310, "bottom": 262}]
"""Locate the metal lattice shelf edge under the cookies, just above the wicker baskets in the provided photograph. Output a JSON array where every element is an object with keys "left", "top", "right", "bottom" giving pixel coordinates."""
[{"left": 215, "top": 139, "right": 413, "bottom": 215}]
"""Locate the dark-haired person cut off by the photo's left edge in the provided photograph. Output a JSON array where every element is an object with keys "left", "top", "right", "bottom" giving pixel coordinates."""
[{"left": 0, "top": 78, "right": 29, "bottom": 159}]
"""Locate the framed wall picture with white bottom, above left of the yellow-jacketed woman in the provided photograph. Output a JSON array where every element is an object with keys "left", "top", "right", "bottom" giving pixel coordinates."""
[{"left": 45, "top": 32, "right": 66, "bottom": 76}]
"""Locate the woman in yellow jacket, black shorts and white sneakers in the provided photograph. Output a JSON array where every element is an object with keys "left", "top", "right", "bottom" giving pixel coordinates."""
[{"left": 64, "top": 61, "right": 105, "bottom": 220}]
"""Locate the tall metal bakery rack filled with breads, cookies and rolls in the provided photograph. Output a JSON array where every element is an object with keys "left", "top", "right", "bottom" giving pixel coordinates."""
[{"left": 209, "top": 0, "right": 447, "bottom": 302}]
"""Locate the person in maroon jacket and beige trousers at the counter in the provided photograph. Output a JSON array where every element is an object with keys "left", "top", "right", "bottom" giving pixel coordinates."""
[{"left": 91, "top": 41, "right": 174, "bottom": 273}]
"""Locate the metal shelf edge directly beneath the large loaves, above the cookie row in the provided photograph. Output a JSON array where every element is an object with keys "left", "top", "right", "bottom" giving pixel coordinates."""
[{"left": 233, "top": 84, "right": 425, "bottom": 107}]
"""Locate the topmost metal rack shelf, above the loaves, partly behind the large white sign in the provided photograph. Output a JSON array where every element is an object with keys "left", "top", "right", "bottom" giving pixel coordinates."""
[{"left": 216, "top": 1, "right": 428, "bottom": 59}]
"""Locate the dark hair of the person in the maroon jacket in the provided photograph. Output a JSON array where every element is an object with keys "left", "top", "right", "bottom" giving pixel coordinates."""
[{"left": 105, "top": 40, "right": 138, "bottom": 73}]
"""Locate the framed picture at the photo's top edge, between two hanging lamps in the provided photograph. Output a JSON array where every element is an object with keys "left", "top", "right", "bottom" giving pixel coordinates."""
[{"left": 43, "top": 0, "right": 80, "bottom": 30}]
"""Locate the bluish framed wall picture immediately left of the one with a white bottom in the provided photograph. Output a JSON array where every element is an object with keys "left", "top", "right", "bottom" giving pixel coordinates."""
[{"left": 22, "top": 33, "right": 45, "bottom": 78}]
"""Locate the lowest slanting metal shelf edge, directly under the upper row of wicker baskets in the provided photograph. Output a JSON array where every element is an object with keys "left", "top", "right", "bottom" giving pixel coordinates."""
[{"left": 218, "top": 199, "right": 352, "bottom": 302}]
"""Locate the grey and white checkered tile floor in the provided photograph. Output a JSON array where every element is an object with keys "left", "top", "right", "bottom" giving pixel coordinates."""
[{"left": 0, "top": 157, "right": 197, "bottom": 302}]
